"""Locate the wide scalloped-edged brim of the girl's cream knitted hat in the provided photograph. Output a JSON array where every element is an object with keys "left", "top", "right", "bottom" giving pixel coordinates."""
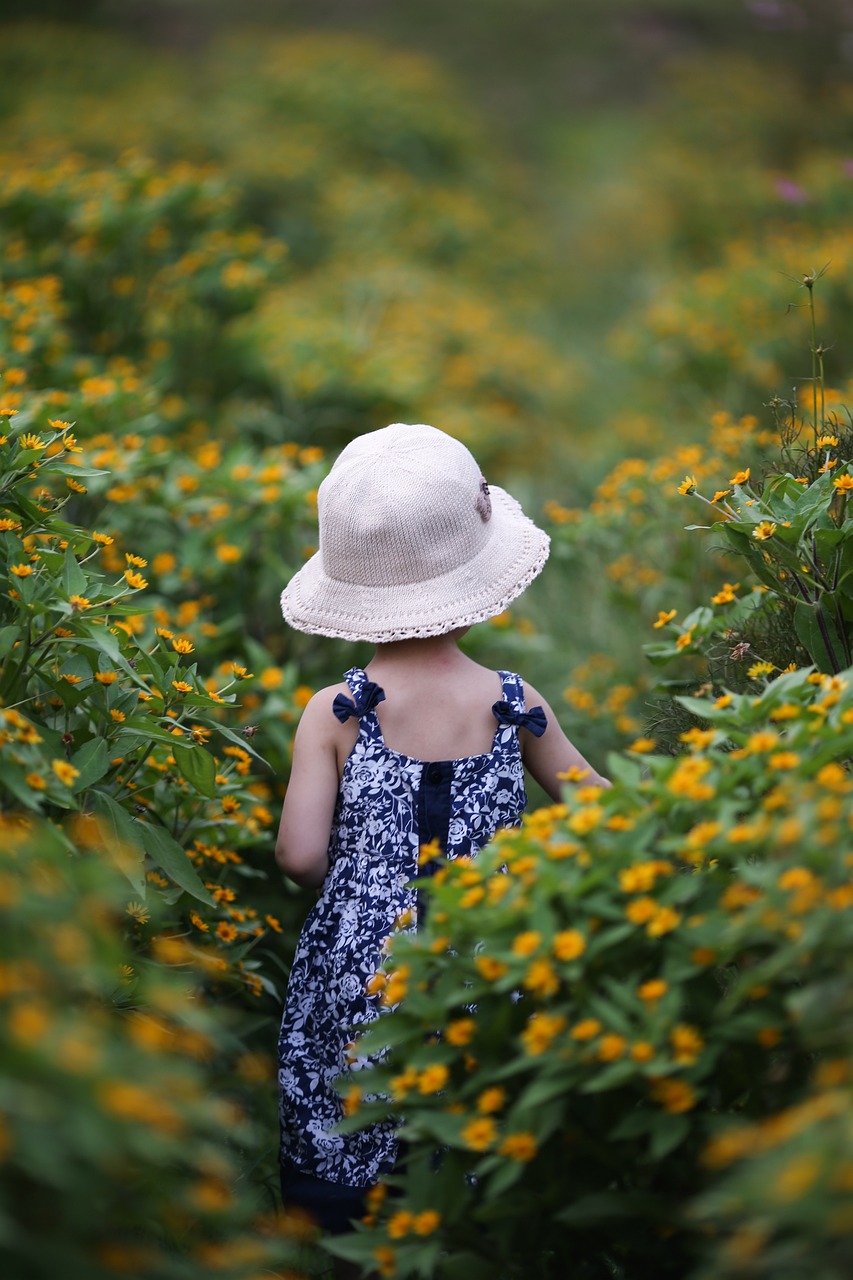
[{"left": 275, "top": 485, "right": 551, "bottom": 644}]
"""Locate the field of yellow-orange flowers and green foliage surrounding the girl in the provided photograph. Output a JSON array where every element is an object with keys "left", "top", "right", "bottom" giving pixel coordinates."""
[{"left": 0, "top": 12, "right": 853, "bottom": 1280}]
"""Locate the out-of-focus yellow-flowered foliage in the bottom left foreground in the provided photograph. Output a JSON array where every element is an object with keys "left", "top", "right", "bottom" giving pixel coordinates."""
[{"left": 0, "top": 819, "right": 311, "bottom": 1280}]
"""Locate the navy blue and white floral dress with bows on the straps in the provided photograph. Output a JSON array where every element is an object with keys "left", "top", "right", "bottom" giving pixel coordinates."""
[{"left": 278, "top": 667, "right": 546, "bottom": 1189}]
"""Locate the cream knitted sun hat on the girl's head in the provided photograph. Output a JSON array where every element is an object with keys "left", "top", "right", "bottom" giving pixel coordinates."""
[{"left": 275, "top": 422, "right": 549, "bottom": 644}]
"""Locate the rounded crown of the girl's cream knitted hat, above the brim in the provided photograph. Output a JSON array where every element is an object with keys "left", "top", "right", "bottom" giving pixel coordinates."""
[{"left": 318, "top": 422, "right": 489, "bottom": 588}]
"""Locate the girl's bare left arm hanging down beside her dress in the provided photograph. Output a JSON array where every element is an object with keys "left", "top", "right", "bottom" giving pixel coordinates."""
[{"left": 275, "top": 689, "right": 341, "bottom": 888}]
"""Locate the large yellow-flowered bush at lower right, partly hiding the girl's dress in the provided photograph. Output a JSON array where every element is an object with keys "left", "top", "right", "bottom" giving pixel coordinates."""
[{"left": 334, "top": 668, "right": 853, "bottom": 1280}]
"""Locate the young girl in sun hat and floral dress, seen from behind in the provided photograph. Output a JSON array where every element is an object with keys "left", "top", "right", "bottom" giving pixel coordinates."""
[{"left": 275, "top": 424, "right": 608, "bottom": 1230}]
